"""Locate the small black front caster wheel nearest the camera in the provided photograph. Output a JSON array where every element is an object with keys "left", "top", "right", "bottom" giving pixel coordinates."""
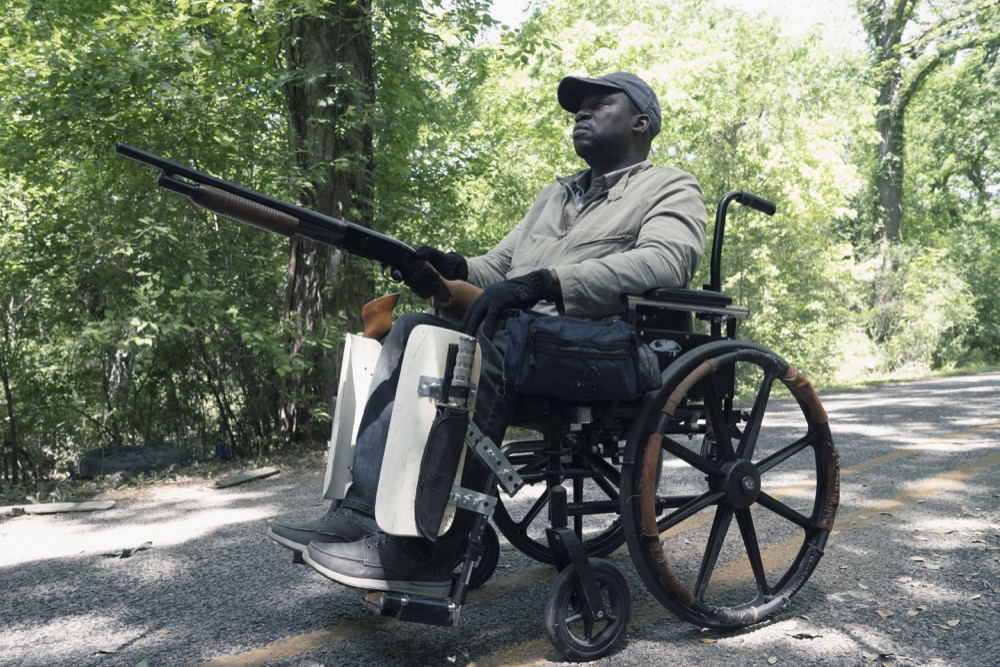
[{"left": 545, "top": 558, "right": 632, "bottom": 661}]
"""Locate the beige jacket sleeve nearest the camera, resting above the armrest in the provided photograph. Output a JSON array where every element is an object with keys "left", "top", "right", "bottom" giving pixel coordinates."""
[{"left": 556, "top": 170, "right": 708, "bottom": 317}]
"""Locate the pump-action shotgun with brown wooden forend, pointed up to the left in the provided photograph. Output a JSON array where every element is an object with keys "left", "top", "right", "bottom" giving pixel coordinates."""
[{"left": 115, "top": 142, "right": 481, "bottom": 338}]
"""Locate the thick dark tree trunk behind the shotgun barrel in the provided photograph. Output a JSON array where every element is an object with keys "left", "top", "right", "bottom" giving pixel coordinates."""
[{"left": 281, "top": 0, "right": 373, "bottom": 440}]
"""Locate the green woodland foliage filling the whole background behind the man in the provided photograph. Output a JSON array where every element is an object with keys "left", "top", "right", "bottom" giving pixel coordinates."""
[{"left": 0, "top": 0, "right": 1000, "bottom": 483}]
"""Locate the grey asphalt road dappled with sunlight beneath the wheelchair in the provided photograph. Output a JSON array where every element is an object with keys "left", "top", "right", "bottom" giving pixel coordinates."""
[{"left": 0, "top": 373, "right": 1000, "bottom": 667}]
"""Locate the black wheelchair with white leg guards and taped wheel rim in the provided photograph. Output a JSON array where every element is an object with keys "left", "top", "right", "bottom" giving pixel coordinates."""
[{"left": 316, "top": 190, "right": 839, "bottom": 661}]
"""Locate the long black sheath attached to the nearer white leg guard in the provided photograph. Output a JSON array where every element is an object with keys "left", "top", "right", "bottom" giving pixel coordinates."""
[{"left": 413, "top": 407, "right": 469, "bottom": 542}]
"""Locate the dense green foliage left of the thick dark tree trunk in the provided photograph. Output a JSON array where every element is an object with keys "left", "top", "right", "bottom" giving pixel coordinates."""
[{"left": 0, "top": 1, "right": 292, "bottom": 474}]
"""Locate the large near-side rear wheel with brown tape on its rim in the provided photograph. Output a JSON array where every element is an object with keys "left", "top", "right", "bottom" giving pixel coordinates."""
[{"left": 622, "top": 340, "right": 840, "bottom": 629}]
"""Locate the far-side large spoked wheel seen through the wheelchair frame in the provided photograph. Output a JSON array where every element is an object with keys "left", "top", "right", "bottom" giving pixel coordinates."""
[{"left": 493, "top": 451, "right": 625, "bottom": 565}]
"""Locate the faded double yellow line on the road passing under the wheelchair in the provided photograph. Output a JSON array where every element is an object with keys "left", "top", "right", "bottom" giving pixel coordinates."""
[{"left": 197, "top": 420, "right": 1000, "bottom": 667}]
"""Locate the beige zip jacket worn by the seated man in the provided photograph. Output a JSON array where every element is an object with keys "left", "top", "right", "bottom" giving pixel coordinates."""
[{"left": 469, "top": 161, "right": 707, "bottom": 318}]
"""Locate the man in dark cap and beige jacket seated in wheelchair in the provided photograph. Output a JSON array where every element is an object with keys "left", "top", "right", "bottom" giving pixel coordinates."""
[{"left": 268, "top": 72, "right": 707, "bottom": 597}]
